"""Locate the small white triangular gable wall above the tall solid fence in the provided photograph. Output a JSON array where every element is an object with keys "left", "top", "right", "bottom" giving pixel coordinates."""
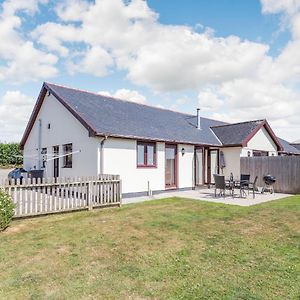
[{"left": 241, "top": 128, "right": 277, "bottom": 156}]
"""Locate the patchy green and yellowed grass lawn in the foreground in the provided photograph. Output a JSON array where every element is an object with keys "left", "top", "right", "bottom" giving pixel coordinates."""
[{"left": 0, "top": 196, "right": 300, "bottom": 300}]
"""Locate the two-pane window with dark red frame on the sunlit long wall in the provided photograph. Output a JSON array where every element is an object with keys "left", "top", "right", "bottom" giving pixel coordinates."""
[{"left": 137, "top": 142, "right": 156, "bottom": 167}]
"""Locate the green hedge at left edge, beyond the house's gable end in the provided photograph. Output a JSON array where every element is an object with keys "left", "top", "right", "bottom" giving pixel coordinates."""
[{"left": 0, "top": 143, "right": 23, "bottom": 167}]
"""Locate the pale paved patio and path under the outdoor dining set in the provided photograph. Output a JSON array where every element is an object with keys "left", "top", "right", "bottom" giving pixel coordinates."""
[{"left": 122, "top": 188, "right": 292, "bottom": 206}]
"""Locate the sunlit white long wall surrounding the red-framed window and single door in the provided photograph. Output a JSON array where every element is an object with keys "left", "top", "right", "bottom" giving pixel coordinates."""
[{"left": 103, "top": 138, "right": 194, "bottom": 193}]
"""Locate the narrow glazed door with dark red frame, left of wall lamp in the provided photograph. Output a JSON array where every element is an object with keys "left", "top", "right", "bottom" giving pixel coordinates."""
[{"left": 165, "top": 144, "right": 177, "bottom": 188}]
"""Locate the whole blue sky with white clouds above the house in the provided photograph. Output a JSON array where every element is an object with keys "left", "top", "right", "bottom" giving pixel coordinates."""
[{"left": 0, "top": 0, "right": 300, "bottom": 142}]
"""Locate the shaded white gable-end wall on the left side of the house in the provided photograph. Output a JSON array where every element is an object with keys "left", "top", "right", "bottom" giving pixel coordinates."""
[{"left": 24, "top": 95, "right": 100, "bottom": 177}]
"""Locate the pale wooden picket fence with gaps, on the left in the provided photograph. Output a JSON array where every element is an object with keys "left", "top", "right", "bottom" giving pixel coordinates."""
[{"left": 0, "top": 175, "right": 122, "bottom": 218}]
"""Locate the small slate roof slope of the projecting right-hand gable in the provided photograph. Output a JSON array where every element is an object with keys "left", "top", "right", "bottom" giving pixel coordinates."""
[{"left": 212, "top": 120, "right": 265, "bottom": 146}]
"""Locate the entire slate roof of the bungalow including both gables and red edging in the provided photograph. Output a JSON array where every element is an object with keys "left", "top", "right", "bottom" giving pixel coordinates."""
[{"left": 21, "top": 83, "right": 300, "bottom": 153}]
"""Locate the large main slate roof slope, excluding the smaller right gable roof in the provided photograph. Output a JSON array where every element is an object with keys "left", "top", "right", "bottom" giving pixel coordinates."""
[{"left": 44, "top": 83, "right": 225, "bottom": 146}]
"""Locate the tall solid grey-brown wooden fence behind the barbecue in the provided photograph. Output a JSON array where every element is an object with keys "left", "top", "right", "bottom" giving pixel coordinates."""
[{"left": 241, "top": 156, "right": 300, "bottom": 194}]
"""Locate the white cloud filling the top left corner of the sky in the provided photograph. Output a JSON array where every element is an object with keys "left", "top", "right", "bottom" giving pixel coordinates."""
[{"left": 0, "top": 0, "right": 57, "bottom": 82}]
